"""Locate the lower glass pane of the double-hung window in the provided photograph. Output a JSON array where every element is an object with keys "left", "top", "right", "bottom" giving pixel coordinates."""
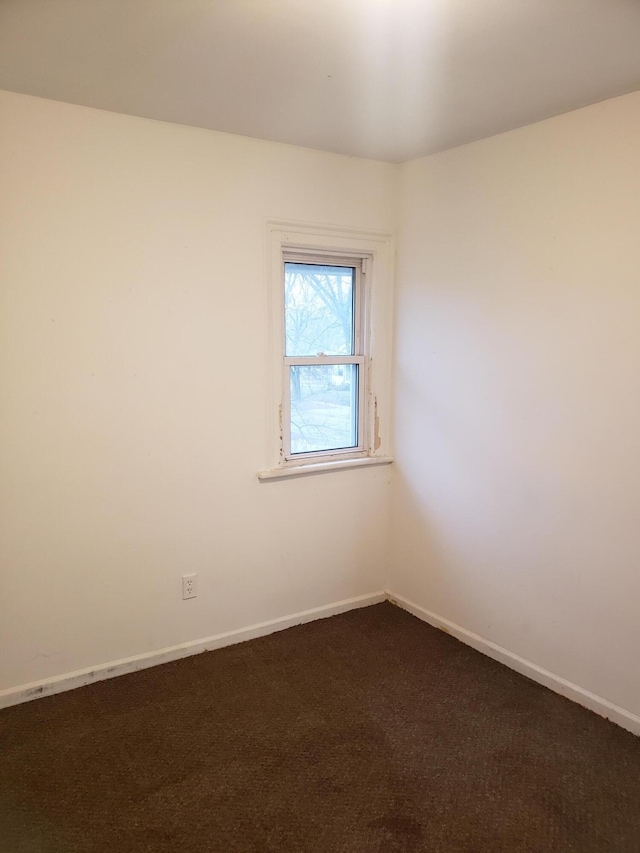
[{"left": 289, "top": 364, "right": 358, "bottom": 454}]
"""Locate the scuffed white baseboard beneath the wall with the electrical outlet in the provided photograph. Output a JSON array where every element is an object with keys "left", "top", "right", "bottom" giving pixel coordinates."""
[{"left": 0, "top": 591, "right": 387, "bottom": 708}]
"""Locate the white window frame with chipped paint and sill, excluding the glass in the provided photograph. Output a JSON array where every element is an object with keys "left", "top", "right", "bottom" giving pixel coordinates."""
[{"left": 258, "top": 220, "right": 394, "bottom": 480}]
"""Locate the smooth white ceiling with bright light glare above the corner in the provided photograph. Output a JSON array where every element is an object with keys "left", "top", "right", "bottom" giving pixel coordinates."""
[{"left": 0, "top": 0, "right": 640, "bottom": 162}]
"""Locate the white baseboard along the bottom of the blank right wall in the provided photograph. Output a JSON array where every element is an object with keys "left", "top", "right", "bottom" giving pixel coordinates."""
[{"left": 387, "top": 592, "right": 640, "bottom": 735}]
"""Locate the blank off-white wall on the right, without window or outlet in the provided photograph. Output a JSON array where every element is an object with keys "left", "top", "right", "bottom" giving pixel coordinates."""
[{"left": 391, "top": 94, "right": 640, "bottom": 714}]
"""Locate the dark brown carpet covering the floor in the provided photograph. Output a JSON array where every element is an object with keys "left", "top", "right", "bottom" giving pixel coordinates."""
[{"left": 0, "top": 604, "right": 640, "bottom": 853}]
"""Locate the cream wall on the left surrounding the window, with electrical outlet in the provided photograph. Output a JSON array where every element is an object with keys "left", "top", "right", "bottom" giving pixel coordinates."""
[{"left": 0, "top": 93, "right": 397, "bottom": 689}]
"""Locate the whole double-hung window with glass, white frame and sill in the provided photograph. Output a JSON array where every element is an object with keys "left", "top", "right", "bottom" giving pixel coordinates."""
[{"left": 258, "top": 223, "right": 392, "bottom": 479}]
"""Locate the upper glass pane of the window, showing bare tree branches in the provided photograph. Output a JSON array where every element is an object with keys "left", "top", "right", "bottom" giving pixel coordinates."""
[{"left": 284, "top": 263, "right": 355, "bottom": 356}]
